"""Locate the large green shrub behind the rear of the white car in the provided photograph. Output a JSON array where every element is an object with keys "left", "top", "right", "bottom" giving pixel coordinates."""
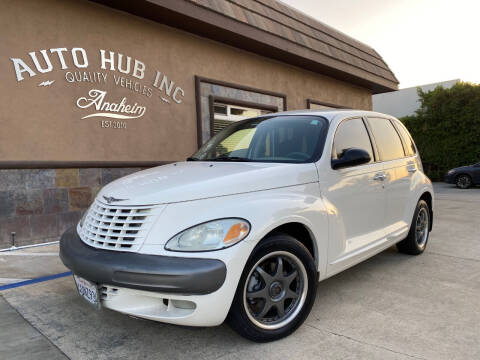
[{"left": 400, "top": 82, "right": 480, "bottom": 181}]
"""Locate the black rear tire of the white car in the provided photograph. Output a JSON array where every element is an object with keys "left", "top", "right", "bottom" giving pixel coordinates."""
[{"left": 397, "top": 200, "right": 432, "bottom": 255}]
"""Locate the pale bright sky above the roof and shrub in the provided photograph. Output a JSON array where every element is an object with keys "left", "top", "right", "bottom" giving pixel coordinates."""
[{"left": 282, "top": 0, "right": 480, "bottom": 89}]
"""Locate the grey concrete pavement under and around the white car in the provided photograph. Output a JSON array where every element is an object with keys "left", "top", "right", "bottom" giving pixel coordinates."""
[{"left": 0, "top": 184, "right": 480, "bottom": 360}]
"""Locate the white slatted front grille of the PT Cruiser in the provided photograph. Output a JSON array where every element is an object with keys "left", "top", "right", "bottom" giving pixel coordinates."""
[{"left": 79, "top": 200, "right": 158, "bottom": 251}]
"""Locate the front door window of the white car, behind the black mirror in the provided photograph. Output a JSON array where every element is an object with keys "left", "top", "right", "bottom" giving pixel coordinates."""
[{"left": 332, "top": 119, "right": 374, "bottom": 162}]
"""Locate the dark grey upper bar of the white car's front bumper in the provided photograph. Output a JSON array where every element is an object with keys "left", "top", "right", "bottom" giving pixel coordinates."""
[{"left": 60, "top": 228, "right": 227, "bottom": 295}]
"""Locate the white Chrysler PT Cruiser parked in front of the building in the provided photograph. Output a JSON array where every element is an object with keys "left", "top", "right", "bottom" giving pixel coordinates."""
[{"left": 60, "top": 110, "right": 433, "bottom": 341}]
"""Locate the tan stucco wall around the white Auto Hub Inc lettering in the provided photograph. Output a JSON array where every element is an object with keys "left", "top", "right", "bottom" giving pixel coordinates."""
[{"left": 0, "top": 0, "right": 371, "bottom": 161}]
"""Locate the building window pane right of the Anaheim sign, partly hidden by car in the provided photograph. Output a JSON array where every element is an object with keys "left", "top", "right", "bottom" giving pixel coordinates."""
[{"left": 213, "top": 102, "right": 272, "bottom": 135}]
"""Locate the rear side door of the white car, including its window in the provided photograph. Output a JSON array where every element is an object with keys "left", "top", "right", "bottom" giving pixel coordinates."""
[{"left": 368, "top": 117, "right": 408, "bottom": 241}]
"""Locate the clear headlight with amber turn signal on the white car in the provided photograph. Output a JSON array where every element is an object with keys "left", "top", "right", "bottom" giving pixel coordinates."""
[{"left": 165, "top": 219, "right": 250, "bottom": 251}]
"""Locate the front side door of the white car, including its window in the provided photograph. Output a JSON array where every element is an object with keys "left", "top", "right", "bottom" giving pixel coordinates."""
[{"left": 319, "top": 117, "right": 385, "bottom": 274}]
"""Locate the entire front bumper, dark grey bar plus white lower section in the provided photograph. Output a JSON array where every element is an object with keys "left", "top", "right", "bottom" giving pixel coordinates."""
[{"left": 60, "top": 228, "right": 240, "bottom": 326}]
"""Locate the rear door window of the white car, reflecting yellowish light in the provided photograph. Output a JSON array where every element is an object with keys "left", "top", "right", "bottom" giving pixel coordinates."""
[{"left": 368, "top": 118, "right": 405, "bottom": 161}]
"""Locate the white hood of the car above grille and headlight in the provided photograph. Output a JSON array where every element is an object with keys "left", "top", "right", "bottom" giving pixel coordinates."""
[{"left": 97, "top": 161, "right": 318, "bottom": 205}]
